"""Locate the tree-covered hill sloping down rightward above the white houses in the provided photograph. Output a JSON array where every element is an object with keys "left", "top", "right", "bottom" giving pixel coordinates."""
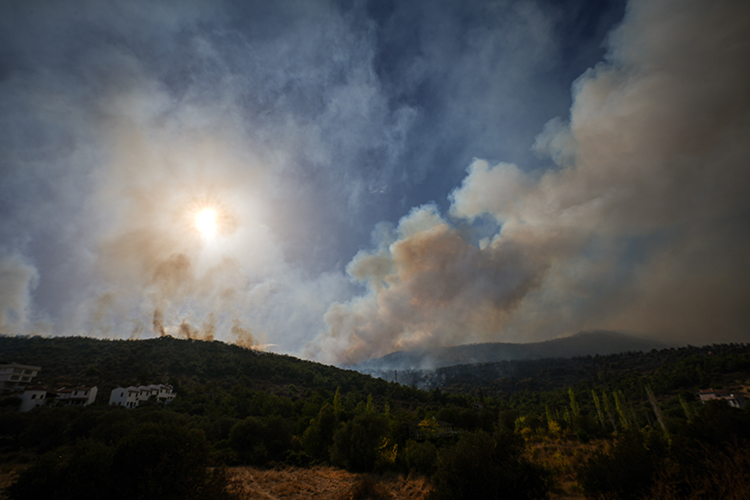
[{"left": 0, "top": 336, "right": 424, "bottom": 406}]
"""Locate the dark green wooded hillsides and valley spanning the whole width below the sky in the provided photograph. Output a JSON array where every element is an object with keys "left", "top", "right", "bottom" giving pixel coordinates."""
[{"left": 0, "top": 337, "right": 750, "bottom": 499}]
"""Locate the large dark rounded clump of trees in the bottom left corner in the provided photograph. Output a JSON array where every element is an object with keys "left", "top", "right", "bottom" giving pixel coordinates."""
[{"left": 8, "top": 417, "right": 231, "bottom": 500}]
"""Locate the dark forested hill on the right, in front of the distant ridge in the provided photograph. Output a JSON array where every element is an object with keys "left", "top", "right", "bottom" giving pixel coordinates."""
[{"left": 398, "top": 344, "right": 750, "bottom": 396}]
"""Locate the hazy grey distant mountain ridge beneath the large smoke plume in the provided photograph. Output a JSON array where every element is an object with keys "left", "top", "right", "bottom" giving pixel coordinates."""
[{"left": 356, "top": 330, "right": 670, "bottom": 373}]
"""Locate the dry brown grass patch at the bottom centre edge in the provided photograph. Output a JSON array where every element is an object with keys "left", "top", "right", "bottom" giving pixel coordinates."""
[{"left": 228, "top": 467, "right": 430, "bottom": 500}]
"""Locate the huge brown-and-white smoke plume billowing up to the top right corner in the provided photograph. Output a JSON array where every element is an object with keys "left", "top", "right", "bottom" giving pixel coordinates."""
[{"left": 310, "top": 0, "right": 750, "bottom": 363}]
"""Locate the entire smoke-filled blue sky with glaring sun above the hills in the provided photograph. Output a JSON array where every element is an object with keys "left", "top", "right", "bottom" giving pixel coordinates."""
[{"left": 0, "top": 0, "right": 750, "bottom": 365}]
